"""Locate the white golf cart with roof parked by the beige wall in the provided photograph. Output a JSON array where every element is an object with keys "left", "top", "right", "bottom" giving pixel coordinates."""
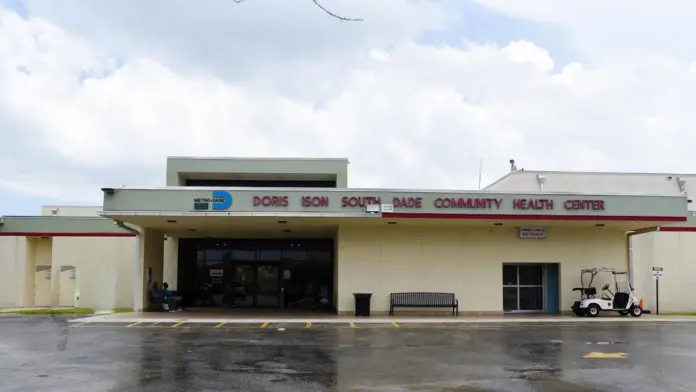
[{"left": 571, "top": 268, "right": 643, "bottom": 317}]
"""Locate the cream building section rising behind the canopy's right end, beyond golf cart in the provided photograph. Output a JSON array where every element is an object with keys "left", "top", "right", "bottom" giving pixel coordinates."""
[{"left": 486, "top": 170, "right": 696, "bottom": 313}]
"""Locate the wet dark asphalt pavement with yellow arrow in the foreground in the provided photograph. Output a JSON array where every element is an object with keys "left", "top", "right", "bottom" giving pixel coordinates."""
[{"left": 0, "top": 316, "right": 696, "bottom": 392}]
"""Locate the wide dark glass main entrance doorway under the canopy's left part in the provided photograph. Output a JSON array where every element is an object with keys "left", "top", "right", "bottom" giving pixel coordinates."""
[{"left": 177, "top": 239, "right": 334, "bottom": 309}]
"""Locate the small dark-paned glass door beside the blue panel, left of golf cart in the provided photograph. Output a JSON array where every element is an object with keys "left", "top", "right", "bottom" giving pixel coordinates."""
[{"left": 503, "top": 264, "right": 544, "bottom": 312}]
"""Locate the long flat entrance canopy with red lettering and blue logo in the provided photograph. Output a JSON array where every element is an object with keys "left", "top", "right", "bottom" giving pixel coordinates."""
[{"left": 102, "top": 187, "right": 687, "bottom": 233}]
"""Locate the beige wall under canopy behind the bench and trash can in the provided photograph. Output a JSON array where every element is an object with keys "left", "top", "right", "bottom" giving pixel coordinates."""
[{"left": 338, "top": 226, "right": 627, "bottom": 314}]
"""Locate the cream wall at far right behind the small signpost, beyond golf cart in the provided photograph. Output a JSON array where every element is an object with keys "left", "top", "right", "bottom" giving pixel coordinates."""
[{"left": 632, "top": 232, "right": 696, "bottom": 313}]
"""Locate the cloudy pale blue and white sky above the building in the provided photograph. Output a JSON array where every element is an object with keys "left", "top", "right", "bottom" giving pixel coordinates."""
[{"left": 0, "top": 0, "right": 696, "bottom": 215}]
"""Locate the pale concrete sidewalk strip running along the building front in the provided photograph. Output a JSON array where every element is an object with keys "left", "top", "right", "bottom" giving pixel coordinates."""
[{"left": 70, "top": 312, "right": 696, "bottom": 324}]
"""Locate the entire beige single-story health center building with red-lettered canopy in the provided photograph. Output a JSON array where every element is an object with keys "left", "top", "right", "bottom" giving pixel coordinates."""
[{"left": 0, "top": 158, "right": 696, "bottom": 315}]
